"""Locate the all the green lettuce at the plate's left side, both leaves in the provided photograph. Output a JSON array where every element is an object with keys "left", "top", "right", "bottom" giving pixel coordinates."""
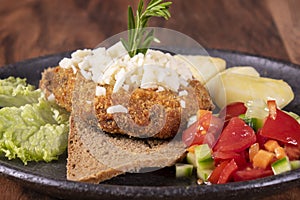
[{"left": 0, "top": 77, "right": 69, "bottom": 164}]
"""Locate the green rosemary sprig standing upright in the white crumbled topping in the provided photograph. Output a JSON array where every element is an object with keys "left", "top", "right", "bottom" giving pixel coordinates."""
[{"left": 121, "top": 0, "right": 172, "bottom": 57}]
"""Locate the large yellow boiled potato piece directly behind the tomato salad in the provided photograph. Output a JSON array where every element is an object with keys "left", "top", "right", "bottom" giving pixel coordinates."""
[{"left": 206, "top": 68, "right": 294, "bottom": 108}]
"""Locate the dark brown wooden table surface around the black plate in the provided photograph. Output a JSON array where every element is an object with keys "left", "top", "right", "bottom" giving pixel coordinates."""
[{"left": 0, "top": 0, "right": 300, "bottom": 200}]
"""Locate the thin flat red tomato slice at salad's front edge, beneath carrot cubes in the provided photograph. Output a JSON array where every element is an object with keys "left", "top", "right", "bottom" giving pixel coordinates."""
[{"left": 233, "top": 169, "right": 273, "bottom": 181}]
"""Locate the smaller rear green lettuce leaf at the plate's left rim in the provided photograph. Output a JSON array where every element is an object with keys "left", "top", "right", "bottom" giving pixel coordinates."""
[{"left": 0, "top": 77, "right": 43, "bottom": 107}]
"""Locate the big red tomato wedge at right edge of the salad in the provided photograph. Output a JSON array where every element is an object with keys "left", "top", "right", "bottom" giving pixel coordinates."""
[{"left": 261, "top": 101, "right": 300, "bottom": 146}]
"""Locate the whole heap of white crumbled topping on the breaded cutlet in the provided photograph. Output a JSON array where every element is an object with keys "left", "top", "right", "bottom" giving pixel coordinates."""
[{"left": 59, "top": 42, "right": 193, "bottom": 92}]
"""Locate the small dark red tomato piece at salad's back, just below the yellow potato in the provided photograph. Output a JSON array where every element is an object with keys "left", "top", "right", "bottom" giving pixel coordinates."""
[{"left": 219, "top": 102, "right": 247, "bottom": 121}]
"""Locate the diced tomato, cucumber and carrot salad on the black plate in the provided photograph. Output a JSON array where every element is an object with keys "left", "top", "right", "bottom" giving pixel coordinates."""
[{"left": 178, "top": 100, "right": 300, "bottom": 184}]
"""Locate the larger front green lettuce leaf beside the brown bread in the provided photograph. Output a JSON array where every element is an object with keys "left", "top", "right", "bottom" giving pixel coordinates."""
[{"left": 0, "top": 98, "right": 69, "bottom": 164}]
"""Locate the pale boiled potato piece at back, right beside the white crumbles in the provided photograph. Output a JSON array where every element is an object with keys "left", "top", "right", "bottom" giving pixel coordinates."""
[{"left": 174, "top": 55, "right": 226, "bottom": 84}]
